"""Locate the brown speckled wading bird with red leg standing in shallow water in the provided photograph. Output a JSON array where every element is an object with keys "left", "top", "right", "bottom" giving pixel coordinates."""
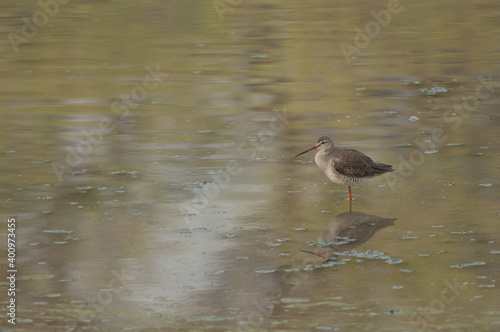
[{"left": 295, "top": 136, "right": 395, "bottom": 202}]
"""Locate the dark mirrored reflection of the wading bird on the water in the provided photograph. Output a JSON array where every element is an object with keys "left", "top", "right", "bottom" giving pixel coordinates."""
[{"left": 302, "top": 211, "right": 397, "bottom": 262}]
